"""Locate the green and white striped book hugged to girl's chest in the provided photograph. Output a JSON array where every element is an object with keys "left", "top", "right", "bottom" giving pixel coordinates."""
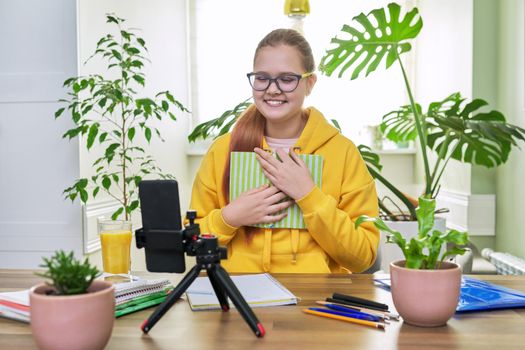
[{"left": 230, "top": 152, "right": 323, "bottom": 229}]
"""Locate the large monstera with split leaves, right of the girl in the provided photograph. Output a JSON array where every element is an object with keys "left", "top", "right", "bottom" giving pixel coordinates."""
[{"left": 319, "top": 3, "right": 525, "bottom": 220}]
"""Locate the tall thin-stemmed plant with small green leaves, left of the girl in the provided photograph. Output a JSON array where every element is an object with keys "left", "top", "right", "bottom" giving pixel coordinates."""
[{"left": 55, "top": 14, "right": 189, "bottom": 220}]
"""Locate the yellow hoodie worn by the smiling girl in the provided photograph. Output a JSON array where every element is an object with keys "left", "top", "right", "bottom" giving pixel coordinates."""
[{"left": 190, "top": 107, "right": 379, "bottom": 273}]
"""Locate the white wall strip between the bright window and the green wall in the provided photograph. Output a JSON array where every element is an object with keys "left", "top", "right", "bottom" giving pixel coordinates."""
[{"left": 414, "top": 0, "right": 473, "bottom": 193}]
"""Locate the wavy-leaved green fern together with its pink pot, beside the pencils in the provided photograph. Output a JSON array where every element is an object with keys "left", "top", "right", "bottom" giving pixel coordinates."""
[{"left": 355, "top": 197, "right": 468, "bottom": 327}]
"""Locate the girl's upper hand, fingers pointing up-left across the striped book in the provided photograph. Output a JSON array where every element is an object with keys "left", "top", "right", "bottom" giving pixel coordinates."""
[{"left": 254, "top": 148, "right": 315, "bottom": 200}]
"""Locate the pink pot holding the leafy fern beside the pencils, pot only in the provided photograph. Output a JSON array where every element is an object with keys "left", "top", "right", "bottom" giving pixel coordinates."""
[{"left": 390, "top": 260, "right": 461, "bottom": 327}]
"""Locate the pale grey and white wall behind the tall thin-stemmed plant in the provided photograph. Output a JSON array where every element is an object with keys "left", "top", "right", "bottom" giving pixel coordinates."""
[{"left": 0, "top": 0, "right": 188, "bottom": 270}]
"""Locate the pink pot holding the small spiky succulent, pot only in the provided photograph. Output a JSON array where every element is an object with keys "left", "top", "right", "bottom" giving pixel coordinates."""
[{"left": 29, "top": 281, "right": 115, "bottom": 350}]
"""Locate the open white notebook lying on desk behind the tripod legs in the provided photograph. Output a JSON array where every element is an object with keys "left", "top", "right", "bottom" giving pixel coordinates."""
[{"left": 186, "top": 273, "right": 299, "bottom": 311}]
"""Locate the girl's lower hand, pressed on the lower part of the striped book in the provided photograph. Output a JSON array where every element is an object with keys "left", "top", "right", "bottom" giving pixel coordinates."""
[{"left": 222, "top": 185, "right": 293, "bottom": 227}]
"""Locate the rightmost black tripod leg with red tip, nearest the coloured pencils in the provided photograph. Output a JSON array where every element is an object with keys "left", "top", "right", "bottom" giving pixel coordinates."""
[{"left": 208, "top": 264, "right": 266, "bottom": 337}]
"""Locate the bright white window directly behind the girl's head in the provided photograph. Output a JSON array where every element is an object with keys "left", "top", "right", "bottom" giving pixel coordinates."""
[{"left": 189, "top": 0, "right": 410, "bottom": 143}]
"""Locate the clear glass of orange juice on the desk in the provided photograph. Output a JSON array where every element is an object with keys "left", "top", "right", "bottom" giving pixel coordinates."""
[{"left": 98, "top": 220, "right": 132, "bottom": 279}]
